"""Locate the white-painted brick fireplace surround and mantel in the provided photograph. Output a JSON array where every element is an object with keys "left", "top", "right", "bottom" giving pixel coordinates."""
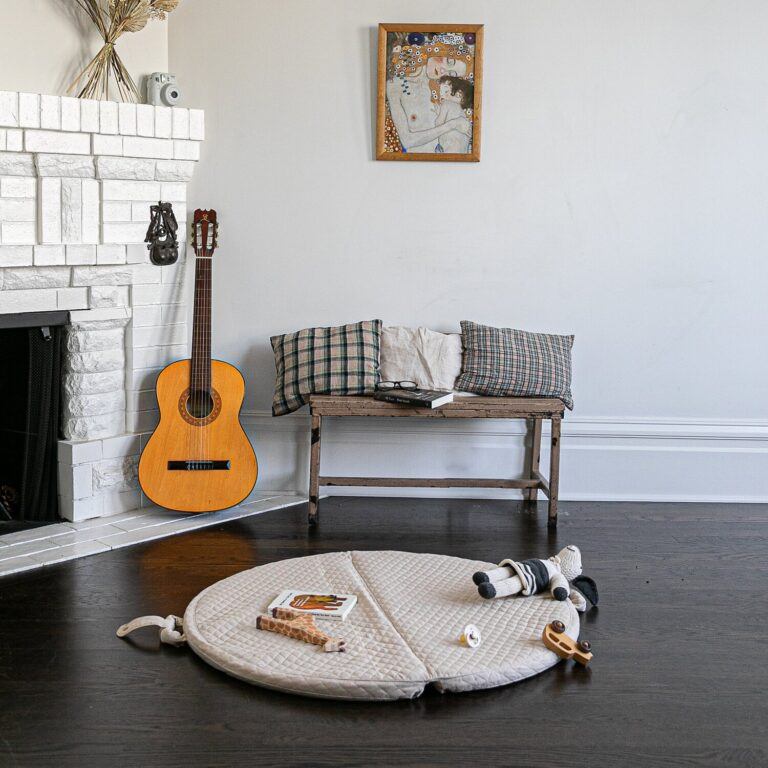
[{"left": 0, "top": 91, "right": 204, "bottom": 520}]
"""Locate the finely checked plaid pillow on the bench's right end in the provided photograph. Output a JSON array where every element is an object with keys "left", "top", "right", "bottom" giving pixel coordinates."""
[{"left": 455, "top": 320, "right": 573, "bottom": 408}]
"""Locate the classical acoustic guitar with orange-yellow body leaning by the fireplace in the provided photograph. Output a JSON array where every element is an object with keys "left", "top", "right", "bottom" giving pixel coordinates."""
[{"left": 139, "top": 210, "right": 258, "bottom": 512}]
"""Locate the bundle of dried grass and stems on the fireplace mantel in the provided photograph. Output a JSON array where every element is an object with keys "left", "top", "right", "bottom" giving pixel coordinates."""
[{"left": 67, "top": 0, "right": 180, "bottom": 101}]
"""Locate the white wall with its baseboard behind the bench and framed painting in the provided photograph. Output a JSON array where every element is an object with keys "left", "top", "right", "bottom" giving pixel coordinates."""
[{"left": 164, "top": 0, "right": 768, "bottom": 500}]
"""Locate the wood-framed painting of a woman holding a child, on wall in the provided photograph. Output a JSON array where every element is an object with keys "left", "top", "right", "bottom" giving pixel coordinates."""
[{"left": 376, "top": 24, "right": 483, "bottom": 162}]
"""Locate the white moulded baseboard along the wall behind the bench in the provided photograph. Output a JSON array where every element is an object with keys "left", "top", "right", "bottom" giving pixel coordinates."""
[{"left": 242, "top": 411, "right": 768, "bottom": 503}]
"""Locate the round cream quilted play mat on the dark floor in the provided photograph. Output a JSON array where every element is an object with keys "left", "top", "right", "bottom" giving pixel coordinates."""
[{"left": 118, "top": 552, "right": 579, "bottom": 701}]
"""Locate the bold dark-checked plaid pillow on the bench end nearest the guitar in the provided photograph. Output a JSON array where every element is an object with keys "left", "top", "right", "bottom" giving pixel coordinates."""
[{"left": 271, "top": 320, "right": 381, "bottom": 416}]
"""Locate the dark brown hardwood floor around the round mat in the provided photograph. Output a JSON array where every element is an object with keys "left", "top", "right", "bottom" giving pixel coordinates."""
[{"left": 0, "top": 498, "right": 768, "bottom": 768}]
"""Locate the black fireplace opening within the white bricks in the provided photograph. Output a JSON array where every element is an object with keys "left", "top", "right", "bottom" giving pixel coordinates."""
[{"left": 0, "top": 312, "right": 68, "bottom": 533}]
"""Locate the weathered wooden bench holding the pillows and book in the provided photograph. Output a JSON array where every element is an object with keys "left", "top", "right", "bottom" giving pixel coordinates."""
[{"left": 309, "top": 395, "right": 564, "bottom": 527}]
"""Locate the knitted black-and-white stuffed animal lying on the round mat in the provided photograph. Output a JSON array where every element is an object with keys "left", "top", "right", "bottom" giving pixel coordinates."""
[{"left": 472, "top": 545, "right": 598, "bottom": 612}]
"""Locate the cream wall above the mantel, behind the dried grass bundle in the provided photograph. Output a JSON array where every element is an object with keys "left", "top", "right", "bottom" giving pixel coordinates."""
[{"left": 0, "top": 0, "right": 168, "bottom": 95}]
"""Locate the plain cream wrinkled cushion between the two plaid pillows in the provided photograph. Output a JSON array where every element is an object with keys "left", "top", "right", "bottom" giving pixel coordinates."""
[{"left": 380, "top": 326, "right": 461, "bottom": 391}]
